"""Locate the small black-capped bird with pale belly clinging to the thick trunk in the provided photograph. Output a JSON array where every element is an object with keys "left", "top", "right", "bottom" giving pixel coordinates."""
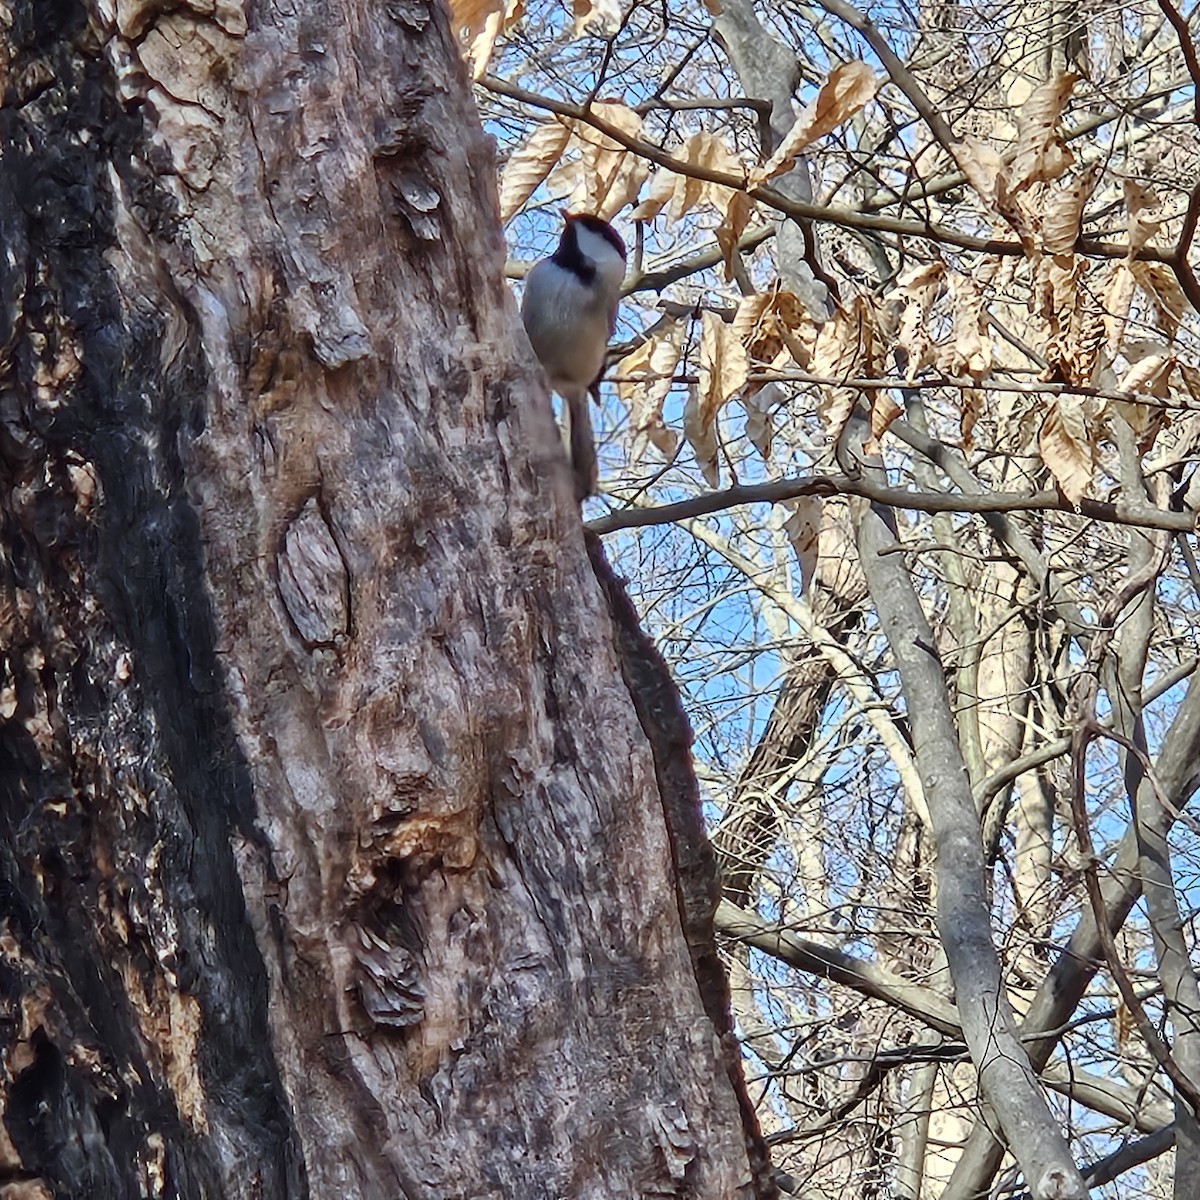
[{"left": 521, "top": 212, "right": 625, "bottom": 500}]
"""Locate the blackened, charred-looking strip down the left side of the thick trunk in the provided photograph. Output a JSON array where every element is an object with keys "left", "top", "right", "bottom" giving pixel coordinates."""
[{"left": 0, "top": 11, "right": 306, "bottom": 1198}]
